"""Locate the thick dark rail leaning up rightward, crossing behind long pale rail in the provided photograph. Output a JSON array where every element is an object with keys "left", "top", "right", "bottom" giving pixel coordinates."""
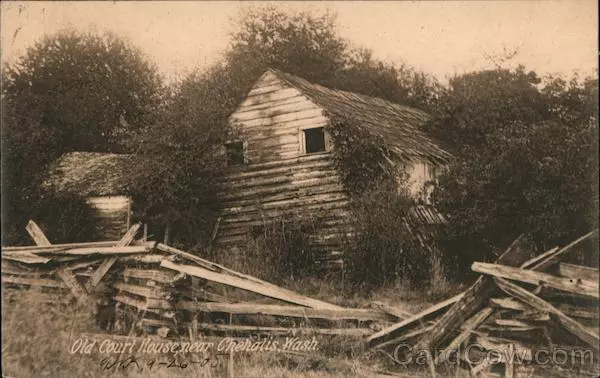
[{"left": 418, "top": 235, "right": 530, "bottom": 350}]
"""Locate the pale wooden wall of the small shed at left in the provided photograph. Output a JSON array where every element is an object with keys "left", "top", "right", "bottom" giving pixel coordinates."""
[{"left": 87, "top": 196, "right": 131, "bottom": 240}]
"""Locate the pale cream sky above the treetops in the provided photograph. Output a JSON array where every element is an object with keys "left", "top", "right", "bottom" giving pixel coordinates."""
[{"left": 0, "top": 0, "right": 598, "bottom": 82}]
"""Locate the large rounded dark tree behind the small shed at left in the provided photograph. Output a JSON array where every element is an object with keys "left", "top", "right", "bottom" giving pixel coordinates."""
[{"left": 1, "top": 31, "right": 162, "bottom": 242}]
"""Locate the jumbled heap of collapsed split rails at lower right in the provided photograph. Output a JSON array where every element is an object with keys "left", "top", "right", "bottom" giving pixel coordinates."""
[{"left": 366, "top": 230, "right": 600, "bottom": 377}]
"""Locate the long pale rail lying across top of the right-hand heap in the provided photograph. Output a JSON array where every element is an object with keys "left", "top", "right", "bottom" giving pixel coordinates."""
[{"left": 471, "top": 262, "right": 600, "bottom": 298}]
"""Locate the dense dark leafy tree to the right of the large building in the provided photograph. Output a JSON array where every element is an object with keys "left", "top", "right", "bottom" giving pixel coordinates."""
[{"left": 429, "top": 67, "right": 598, "bottom": 274}]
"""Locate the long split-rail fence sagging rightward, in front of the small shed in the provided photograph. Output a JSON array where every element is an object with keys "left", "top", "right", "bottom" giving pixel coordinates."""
[{"left": 2, "top": 222, "right": 402, "bottom": 339}]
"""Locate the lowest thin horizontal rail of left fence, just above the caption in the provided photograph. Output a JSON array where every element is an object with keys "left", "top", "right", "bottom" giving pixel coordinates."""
[{"left": 198, "top": 324, "right": 373, "bottom": 338}]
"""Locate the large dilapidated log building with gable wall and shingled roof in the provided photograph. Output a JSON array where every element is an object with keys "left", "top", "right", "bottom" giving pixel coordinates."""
[{"left": 215, "top": 69, "right": 450, "bottom": 262}]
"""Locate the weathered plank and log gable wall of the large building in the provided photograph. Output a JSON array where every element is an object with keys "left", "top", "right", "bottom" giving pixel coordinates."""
[{"left": 215, "top": 72, "right": 348, "bottom": 266}]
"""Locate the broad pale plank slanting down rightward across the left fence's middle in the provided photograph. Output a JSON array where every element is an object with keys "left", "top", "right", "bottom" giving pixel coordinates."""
[{"left": 160, "top": 260, "right": 340, "bottom": 309}]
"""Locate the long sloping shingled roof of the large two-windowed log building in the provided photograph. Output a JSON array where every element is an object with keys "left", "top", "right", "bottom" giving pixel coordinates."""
[{"left": 268, "top": 69, "right": 451, "bottom": 164}]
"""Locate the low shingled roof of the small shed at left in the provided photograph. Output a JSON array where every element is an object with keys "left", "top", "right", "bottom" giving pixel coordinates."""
[{"left": 44, "top": 152, "right": 133, "bottom": 197}]
